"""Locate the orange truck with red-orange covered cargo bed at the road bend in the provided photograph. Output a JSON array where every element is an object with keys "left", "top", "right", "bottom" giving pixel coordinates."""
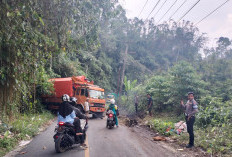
[{"left": 42, "top": 76, "right": 106, "bottom": 117}]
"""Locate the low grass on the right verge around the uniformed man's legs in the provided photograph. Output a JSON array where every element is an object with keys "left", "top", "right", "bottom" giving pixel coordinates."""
[{"left": 149, "top": 115, "right": 232, "bottom": 156}]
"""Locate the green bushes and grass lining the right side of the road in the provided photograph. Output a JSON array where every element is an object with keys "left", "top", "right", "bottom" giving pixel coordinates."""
[{"left": 121, "top": 59, "right": 232, "bottom": 155}]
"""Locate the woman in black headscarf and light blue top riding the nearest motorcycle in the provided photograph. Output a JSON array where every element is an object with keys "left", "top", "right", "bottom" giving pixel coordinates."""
[{"left": 58, "top": 94, "right": 87, "bottom": 148}]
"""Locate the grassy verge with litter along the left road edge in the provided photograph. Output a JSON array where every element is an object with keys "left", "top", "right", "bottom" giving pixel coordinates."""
[{"left": 0, "top": 112, "right": 54, "bottom": 156}]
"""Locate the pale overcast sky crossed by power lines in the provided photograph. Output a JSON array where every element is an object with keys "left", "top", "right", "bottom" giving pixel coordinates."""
[{"left": 119, "top": 0, "right": 232, "bottom": 46}]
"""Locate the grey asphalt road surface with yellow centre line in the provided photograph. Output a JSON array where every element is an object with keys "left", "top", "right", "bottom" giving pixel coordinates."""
[{"left": 16, "top": 119, "right": 183, "bottom": 157}]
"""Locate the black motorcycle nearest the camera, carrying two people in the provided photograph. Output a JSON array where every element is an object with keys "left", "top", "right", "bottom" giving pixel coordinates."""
[{"left": 53, "top": 121, "right": 88, "bottom": 153}]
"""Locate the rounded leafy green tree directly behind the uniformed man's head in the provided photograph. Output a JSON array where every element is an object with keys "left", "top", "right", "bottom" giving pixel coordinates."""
[{"left": 168, "top": 62, "right": 206, "bottom": 109}]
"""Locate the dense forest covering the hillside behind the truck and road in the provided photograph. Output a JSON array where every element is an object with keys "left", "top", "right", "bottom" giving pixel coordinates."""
[{"left": 0, "top": 0, "right": 232, "bottom": 154}]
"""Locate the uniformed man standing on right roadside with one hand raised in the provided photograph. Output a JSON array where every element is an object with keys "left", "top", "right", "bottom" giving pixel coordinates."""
[{"left": 181, "top": 92, "right": 198, "bottom": 148}]
